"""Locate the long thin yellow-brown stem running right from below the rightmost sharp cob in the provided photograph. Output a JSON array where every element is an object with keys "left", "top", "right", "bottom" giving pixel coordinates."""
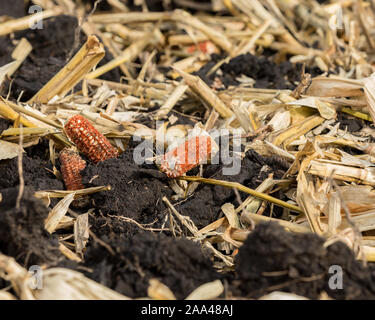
[{"left": 178, "top": 176, "right": 303, "bottom": 213}]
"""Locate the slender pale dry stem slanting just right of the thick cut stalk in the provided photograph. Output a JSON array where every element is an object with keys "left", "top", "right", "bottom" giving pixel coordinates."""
[{"left": 86, "top": 34, "right": 155, "bottom": 79}]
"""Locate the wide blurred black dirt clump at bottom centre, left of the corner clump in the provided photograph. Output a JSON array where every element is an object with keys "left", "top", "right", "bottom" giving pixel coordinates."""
[{"left": 85, "top": 232, "right": 221, "bottom": 299}]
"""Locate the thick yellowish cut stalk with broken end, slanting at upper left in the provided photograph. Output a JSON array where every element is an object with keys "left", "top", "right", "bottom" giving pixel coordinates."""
[{"left": 29, "top": 36, "right": 105, "bottom": 103}]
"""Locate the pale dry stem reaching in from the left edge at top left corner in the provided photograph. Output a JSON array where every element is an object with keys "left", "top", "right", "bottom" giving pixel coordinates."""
[{"left": 0, "top": 9, "right": 61, "bottom": 36}]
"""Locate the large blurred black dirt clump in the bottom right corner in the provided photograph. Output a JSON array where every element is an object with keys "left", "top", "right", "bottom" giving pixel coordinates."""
[{"left": 234, "top": 223, "right": 375, "bottom": 300}]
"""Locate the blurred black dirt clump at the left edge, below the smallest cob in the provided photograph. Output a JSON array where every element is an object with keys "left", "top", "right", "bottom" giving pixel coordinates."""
[{"left": 0, "top": 187, "right": 63, "bottom": 266}]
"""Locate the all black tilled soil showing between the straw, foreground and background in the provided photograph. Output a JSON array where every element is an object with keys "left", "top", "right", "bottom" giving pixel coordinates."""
[{"left": 0, "top": 0, "right": 375, "bottom": 299}]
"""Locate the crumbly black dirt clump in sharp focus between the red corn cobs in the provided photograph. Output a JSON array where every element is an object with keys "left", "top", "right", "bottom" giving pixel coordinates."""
[{"left": 82, "top": 140, "right": 172, "bottom": 230}]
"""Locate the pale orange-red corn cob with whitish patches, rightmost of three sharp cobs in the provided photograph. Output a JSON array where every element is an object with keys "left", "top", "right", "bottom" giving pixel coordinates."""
[{"left": 160, "top": 134, "right": 218, "bottom": 178}]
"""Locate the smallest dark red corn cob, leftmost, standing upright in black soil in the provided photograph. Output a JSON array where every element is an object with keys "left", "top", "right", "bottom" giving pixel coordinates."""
[{"left": 60, "top": 148, "right": 86, "bottom": 190}]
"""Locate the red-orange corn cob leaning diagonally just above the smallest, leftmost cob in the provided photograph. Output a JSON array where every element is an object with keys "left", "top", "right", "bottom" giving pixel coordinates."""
[{"left": 64, "top": 115, "right": 118, "bottom": 163}]
